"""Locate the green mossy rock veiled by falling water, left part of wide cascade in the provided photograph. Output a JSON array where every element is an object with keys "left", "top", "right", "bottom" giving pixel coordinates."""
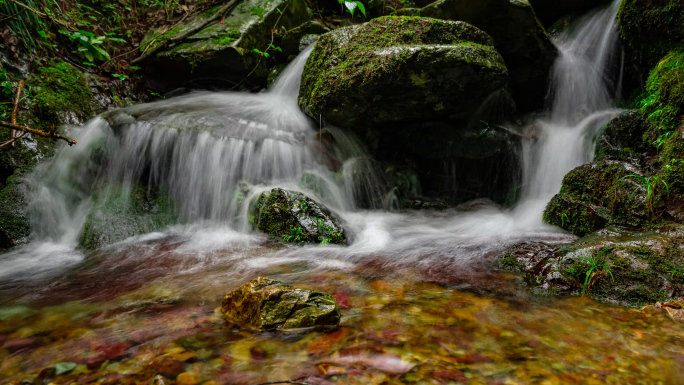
[{"left": 81, "top": 187, "right": 178, "bottom": 250}]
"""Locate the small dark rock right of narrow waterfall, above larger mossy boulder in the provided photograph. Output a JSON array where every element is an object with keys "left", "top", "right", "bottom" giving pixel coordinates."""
[{"left": 594, "top": 110, "right": 653, "bottom": 165}]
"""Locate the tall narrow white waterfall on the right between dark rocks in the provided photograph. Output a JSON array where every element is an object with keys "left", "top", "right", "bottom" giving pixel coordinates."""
[{"left": 516, "top": 0, "right": 622, "bottom": 224}]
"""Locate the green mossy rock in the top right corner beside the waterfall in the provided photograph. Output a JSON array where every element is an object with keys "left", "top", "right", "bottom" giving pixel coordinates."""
[{"left": 618, "top": 0, "right": 684, "bottom": 71}]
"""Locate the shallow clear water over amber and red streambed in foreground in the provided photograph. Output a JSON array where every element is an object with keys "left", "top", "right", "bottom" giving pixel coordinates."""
[{"left": 0, "top": 236, "right": 684, "bottom": 384}]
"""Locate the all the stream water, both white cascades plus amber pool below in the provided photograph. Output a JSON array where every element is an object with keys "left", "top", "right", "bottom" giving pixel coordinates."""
[{"left": 5, "top": 0, "right": 684, "bottom": 384}]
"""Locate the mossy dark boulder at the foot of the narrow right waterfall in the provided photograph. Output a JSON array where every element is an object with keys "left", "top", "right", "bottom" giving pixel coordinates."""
[{"left": 543, "top": 161, "right": 666, "bottom": 236}]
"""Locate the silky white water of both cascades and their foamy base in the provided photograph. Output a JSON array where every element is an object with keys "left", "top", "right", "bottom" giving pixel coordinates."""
[{"left": 0, "top": 0, "right": 621, "bottom": 281}]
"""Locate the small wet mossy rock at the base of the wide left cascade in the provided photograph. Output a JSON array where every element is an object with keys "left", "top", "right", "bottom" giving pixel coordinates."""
[{"left": 249, "top": 188, "right": 347, "bottom": 244}]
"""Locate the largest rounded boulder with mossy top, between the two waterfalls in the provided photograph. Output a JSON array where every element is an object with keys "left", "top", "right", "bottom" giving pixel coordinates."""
[{"left": 299, "top": 17, "right": 507, "bottom": 137}]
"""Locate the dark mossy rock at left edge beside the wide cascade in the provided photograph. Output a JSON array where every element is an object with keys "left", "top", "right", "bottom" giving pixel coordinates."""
[{"left": 0, "top": 176, "right": 31, "bottom": 249}]
